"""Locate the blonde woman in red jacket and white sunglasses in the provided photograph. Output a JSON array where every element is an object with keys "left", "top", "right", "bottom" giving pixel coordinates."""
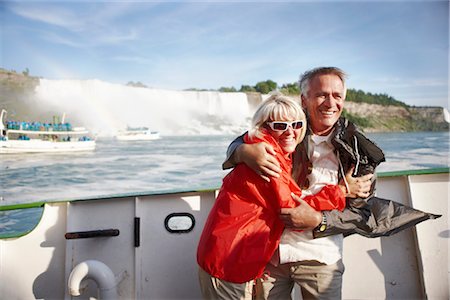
[{"left": 197, "top": 95, "right": 345, "bottom": 299}]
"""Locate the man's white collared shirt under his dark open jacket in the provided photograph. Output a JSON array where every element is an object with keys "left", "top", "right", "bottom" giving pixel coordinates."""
[{"left": 279, "top": 133, "right": 344, "bottom": 265}]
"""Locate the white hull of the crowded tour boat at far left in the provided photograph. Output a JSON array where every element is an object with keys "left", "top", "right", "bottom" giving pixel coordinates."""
[{"left": 0, "top": 139, "right": 95, "bottom": 153}]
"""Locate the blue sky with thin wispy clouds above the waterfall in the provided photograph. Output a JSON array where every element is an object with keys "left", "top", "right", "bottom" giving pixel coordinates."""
[{"left": 0, "top": 0, "right": 449, "bottom": 108}]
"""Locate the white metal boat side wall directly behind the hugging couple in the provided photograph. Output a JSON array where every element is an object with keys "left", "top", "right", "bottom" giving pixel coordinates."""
[{"left": 0, "top": 168, "right": 450, "bottom": 300}]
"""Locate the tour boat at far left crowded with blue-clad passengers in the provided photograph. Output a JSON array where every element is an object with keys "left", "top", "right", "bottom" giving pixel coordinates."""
[{"left": 0, "top": 109, "right": 95, "bottom": 153}]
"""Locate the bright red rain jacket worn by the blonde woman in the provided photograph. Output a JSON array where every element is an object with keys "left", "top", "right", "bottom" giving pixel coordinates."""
[{"left": 197, "top": 133, "right": 345, "bottom": 283}]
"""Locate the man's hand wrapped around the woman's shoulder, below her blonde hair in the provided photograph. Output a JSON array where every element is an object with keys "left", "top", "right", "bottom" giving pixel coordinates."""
[{"left": 235, "top": 143, "right": 281, "bottom": 181}]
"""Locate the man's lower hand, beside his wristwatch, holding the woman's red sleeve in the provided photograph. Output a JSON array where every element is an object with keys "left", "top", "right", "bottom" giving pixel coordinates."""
[{"left": 280, "top": 194, "right": 322, "bottom": 230}]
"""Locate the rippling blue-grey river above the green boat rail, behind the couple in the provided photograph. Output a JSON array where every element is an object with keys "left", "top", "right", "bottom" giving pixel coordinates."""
[{"left": 0, "top": 132, "right": 449, "bottom": 204}]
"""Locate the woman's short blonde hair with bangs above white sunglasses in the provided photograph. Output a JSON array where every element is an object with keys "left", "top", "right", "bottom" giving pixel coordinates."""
[{"left": 248, "top": 94, "right": 306, "bottom": 141}]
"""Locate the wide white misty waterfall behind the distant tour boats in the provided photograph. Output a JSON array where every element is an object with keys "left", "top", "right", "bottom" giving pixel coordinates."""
[{"left": 35, "top": 79, "right": 254, "bottom": 136}]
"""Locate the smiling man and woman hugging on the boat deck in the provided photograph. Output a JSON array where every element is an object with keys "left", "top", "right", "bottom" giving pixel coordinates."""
[{"left": 197, "top": 67, "right": 437, "bottom": 299}]
